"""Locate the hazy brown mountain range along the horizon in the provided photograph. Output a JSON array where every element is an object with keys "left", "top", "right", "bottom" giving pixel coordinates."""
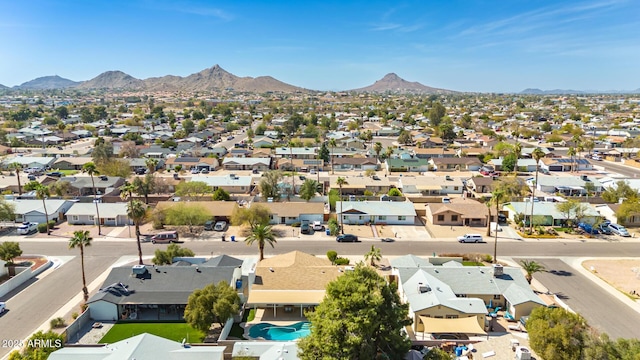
[{"left": 5, "top": 65, "right": 453, "bottom": 94}]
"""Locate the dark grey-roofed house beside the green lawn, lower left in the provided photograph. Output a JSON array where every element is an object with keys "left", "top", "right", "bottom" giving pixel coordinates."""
[{"left": 87, "top": 260, "right": 243, "bottom": 321}]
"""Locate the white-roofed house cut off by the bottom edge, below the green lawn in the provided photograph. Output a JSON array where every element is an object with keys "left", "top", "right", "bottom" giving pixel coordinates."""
[{"left": 48, "top": 333, "right": 226, "bottom": 360}]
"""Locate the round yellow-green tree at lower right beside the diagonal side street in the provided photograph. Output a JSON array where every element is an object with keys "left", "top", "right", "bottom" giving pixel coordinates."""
[{"left": 527, "top": 306, "right": 589, "bottom": 360}]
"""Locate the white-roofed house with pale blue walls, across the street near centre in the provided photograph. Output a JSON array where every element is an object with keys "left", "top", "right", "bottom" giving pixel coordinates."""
[{"left": 336, "top": 201, "right": 416, "bottom": 225}]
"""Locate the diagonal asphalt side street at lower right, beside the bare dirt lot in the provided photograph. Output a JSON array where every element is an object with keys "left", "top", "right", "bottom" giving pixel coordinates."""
[{"left": 534, "top": 259, "right": 640, "bottom": 339}]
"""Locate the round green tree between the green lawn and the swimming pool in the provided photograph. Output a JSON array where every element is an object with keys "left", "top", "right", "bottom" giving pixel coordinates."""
[{"left": 184, "top": 281, "right": 240, "bottom": 333}]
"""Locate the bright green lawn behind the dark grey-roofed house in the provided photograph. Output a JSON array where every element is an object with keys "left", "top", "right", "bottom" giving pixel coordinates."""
[{"left": 99, "top": 322, "right": 205, "bottom": 344}]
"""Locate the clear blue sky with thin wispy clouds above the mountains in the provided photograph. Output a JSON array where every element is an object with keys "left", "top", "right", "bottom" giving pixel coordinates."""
[{"left": 0, "top": 0, "right": 640, "bottom": 92}]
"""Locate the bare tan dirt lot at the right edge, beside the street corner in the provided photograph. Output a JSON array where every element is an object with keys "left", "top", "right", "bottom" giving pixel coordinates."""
[{"left": 582, "top": 259, "right": 640, "bottom": 299}]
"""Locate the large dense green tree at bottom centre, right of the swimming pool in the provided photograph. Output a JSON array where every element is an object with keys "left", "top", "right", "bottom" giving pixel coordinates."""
[{"left": 298, "top": 265, "right": 411, "bottom": 360}]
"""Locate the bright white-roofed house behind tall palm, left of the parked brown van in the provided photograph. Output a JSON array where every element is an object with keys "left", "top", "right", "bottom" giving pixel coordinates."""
[{"left": 66, "top": 203, "right": 133, "bottom": 226}]
